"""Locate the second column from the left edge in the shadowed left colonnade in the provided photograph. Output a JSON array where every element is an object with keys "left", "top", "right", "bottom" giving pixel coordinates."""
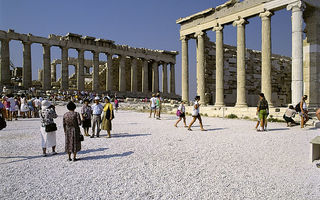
[{"left": 22, "top": 41, "right": 32, "bottom": 88}]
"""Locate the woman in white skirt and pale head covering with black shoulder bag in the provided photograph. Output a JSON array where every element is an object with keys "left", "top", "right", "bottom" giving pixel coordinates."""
[{"left": 40, "top": 100, "right": 58, "bottom": 156}]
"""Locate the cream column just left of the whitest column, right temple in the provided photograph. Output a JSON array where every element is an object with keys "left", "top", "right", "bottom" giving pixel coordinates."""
[{"left": 259, "top": 11, "right": 273, "bottom": 107}]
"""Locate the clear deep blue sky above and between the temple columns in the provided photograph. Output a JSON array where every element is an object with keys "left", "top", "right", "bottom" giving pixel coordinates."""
[{"left": 0, "top": 0, "right": 291, "bottom": 96}]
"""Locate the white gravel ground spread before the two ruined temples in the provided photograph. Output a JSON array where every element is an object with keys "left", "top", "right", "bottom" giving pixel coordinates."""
[{"left": 0, "top": 107, "right": 320, "bottom": 200}]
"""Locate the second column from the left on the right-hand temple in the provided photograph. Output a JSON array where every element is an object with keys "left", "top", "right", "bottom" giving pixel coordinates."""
[{"left": 195, "top": 31, "right": 206, "bottom": 104}]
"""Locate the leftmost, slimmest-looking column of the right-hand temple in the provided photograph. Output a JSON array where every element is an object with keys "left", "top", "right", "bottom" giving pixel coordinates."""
[{"left": 180, "top": 36, "right": 189, "bottom": 101}]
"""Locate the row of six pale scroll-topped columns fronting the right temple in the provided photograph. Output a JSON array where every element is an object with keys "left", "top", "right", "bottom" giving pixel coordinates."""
[{"left": 180, "top": 1, "right": 305, "bottom": 107}]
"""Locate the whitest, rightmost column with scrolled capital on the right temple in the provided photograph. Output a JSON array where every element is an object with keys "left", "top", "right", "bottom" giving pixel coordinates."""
[{"left": 287, "top": 1, "right": 305, "bottom": 105}]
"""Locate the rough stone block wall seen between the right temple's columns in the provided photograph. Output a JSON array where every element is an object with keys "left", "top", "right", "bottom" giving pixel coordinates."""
[{"left": 205, "top": 37, "right": 291, "bottom": 106}]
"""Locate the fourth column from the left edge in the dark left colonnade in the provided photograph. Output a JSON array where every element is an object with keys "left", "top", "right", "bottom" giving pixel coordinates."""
[{"left": 60, "top": 47, "right": 69, "bottom": 90}]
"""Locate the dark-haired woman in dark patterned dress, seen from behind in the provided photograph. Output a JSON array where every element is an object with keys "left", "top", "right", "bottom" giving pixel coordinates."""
[{"left": 63, "top": 101, "right": 83, "bottom": 161}]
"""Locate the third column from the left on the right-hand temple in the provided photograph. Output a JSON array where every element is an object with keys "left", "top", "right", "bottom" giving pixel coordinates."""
[{"left": 213, "top": 25, "right": 225, "bottom": 107}]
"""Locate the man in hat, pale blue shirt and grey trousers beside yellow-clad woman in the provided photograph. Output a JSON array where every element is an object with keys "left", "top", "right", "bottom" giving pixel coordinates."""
[{"left": 90, "top": 96, "right": 103, "bottom": 138}]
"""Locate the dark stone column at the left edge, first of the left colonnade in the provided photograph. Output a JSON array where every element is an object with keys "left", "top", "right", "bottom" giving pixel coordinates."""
[{"left": 0, "top": 39, "right": 11, "bottom": 86}]
